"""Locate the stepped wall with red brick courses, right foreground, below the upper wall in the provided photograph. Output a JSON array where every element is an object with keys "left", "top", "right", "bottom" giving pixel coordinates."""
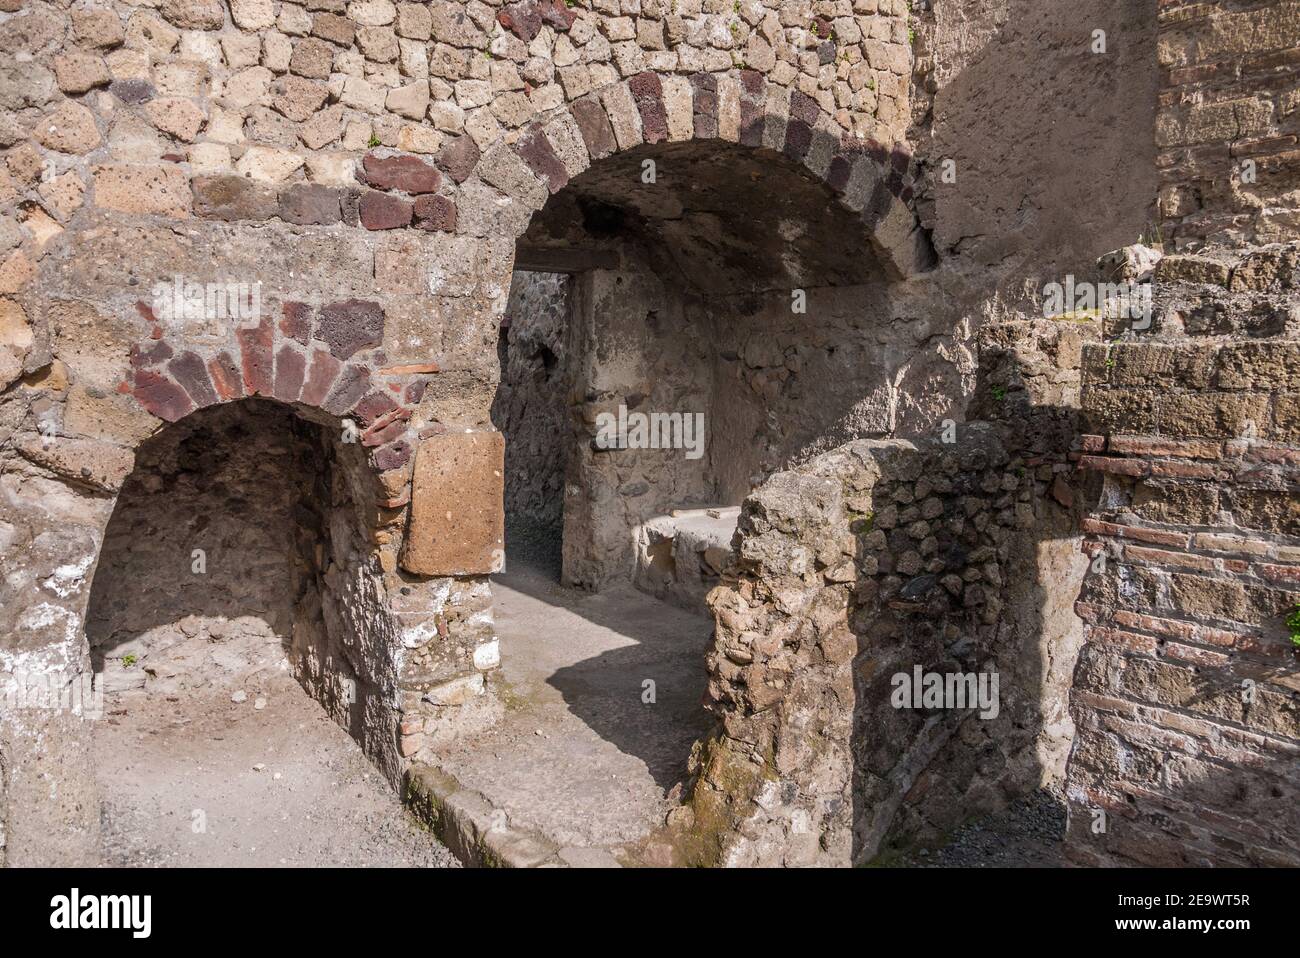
[{"left": 1069, "top": 244, "right": 1300, "bottom": 866}]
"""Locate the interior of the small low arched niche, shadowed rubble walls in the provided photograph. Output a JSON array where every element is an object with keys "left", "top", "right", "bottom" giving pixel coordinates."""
[{"left": 86, "top": 399, "right": 397, "bottom": 767}]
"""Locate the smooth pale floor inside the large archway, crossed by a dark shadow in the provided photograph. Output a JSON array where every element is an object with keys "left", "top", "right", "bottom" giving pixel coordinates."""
[{"left": 442, "top": 560, "right": 711, "bottom": 862}]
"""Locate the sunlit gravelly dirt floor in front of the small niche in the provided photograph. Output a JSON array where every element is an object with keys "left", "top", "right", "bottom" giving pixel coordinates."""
[{"left": 95, "top": 669, "right": 456, "bottom": 868}]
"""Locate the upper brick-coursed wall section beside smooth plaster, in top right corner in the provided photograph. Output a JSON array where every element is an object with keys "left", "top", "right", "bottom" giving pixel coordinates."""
[{"left": 1156, "top": 0, "right": 1300, "bottom": 250}]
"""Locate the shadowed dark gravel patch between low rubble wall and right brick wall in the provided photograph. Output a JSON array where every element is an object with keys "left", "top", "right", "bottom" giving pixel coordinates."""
[{"left": 896, "top": 786, "right": 1069, "bottom": 868}]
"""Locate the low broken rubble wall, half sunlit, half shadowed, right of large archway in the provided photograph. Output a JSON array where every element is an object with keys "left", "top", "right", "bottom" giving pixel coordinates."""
[{"left": 679, "top": 424, "right": 1073, "bottom": 864}]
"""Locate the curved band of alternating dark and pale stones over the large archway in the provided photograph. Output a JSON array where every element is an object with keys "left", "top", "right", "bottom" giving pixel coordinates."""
[{"left": 454, "top": 70, "right": 935, "bottom": 279}]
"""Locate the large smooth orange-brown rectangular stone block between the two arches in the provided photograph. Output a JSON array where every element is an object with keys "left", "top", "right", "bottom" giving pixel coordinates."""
[{"left": 402, "top": 432, "right": 506, "bottom": 576}]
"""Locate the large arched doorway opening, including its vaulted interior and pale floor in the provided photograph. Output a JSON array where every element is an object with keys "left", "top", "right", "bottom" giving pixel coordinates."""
[{"left": 428, "top": 117, "right": 915, "bottom": 863}]
